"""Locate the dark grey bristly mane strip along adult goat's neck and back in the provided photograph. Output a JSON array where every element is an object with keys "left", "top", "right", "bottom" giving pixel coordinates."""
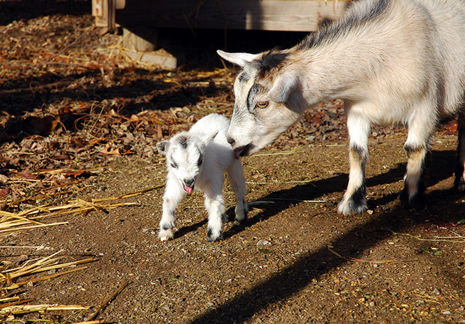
[{"left": 297, "top": 0, "right": 391, "bottom": 50}]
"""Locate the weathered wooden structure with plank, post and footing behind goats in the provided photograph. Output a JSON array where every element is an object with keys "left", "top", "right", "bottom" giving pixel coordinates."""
[{"left": 92, "top": 0, "right": 351, "bottom": 67}]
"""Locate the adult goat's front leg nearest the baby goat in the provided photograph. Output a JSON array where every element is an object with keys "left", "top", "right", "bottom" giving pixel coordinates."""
[{"left": 338, "top": 111, "right": 371, "bottom": 215}]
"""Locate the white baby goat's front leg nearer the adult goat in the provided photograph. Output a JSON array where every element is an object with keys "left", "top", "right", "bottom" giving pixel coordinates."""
[{"left": 205, "top": 184, "right": 226, "bottom": 241}]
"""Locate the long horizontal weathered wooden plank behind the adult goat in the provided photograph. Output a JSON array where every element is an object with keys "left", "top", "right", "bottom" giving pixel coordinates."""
[{"left": 116, "top": 0, "right": 348, "bottom": 31}]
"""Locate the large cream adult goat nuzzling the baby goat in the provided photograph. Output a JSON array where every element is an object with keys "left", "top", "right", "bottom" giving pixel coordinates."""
[{"left": 218, "top": 0, "right": 465, "bottom": 214}]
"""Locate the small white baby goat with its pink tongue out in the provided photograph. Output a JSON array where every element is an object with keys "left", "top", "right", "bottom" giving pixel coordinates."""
[{"left": 157, "top": 114, "right": 247, "bottom": 241}]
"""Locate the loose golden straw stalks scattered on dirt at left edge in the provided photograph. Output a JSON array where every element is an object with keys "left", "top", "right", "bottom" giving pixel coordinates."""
[{"left": 0, "top": 184, "right": 164, "bottom": 324}]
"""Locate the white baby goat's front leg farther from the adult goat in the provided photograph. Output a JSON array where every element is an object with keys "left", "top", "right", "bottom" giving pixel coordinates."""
[{"left": 158, "top": 178, "right": 184, "bottom": 241}]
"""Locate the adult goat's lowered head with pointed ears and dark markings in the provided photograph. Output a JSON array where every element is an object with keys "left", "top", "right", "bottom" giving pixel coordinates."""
[{"left": 218, "top": 50, "right": 305, "bottom": 158}]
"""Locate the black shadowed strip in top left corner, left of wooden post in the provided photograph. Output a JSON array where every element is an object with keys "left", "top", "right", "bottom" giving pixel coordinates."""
[{"left": 0, "top": 0, "right": 91, "bottom": 25}]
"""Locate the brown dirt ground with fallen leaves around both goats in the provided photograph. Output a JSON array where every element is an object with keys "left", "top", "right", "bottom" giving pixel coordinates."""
[{"left": 0, "top": 1, "right": 465, "bottom": 323}]
